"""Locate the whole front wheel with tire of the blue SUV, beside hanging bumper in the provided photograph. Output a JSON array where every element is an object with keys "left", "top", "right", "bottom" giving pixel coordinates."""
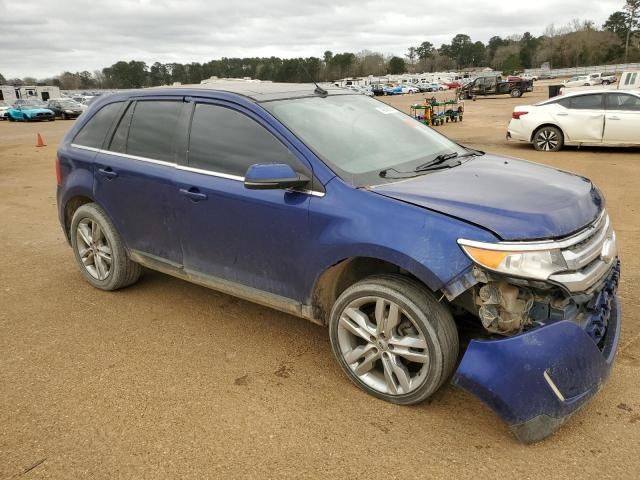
[{"left": 329, "top": 275, "right": 459, "bottom": 405}]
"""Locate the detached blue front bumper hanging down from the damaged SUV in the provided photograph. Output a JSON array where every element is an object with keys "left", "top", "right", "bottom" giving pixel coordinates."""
[{"left": 452, "top": 266, "right": 620, "bottom": 443}]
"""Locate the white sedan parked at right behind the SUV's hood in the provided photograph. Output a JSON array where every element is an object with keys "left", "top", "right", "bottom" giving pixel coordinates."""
[{"left": 507, "top": 89, "right": 640, "bottom": 152}]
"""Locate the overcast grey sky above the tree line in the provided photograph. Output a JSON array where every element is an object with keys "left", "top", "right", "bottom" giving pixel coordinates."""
[{"left": 0, "top": 0, "right": 624, "bottom": 78}]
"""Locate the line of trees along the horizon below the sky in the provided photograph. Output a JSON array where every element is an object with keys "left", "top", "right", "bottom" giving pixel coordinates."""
[{"left": 0, "top": 0, "right": 640, "bottom": 90}]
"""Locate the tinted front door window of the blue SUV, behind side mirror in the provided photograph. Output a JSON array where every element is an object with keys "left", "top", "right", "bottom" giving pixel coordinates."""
[{"left": 189, "top": 103, "right": 301, "bottom": 177}]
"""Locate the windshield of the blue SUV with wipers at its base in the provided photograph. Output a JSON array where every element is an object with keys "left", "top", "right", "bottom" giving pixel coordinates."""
[{"left": 262, "top": 95, "right": 466, "bottom": 187}]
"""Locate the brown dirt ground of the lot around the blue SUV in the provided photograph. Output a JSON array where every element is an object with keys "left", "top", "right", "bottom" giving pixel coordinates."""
[{"left": 0, "top": 82, "right": 640, "bottom": 479}]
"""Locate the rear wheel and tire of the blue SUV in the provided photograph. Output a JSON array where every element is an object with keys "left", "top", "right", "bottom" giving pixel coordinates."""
[{"left": 70, "top": 203, "right": 142, "bottom": 291}]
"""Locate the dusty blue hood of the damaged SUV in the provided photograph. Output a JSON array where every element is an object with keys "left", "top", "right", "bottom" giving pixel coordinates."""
[{"left": 371, "top": 155, "right": 604, "bottom": 241}]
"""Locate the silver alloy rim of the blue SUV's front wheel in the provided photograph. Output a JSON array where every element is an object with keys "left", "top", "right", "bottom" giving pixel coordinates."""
[{"left": 338, "top": 296, "right": 429, "bottom": 395}]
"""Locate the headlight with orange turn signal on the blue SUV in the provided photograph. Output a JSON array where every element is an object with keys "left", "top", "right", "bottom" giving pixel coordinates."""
[{"left": 458, "top": 239, "right": 568, "bottom": 280}]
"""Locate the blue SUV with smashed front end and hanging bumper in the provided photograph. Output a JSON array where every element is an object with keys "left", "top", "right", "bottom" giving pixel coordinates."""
[{"left": 57, "top": 81, "right": 620, "bottom": 442}]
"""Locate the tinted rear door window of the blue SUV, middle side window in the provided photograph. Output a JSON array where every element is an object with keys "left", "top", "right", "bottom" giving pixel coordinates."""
[{"left": 126, "top": 100, "right": 183, "bottom": 162}]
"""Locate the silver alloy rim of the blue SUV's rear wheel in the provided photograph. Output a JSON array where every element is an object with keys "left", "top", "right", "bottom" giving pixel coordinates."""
[{"left": 76, "top": 218, "right": 113, "bottom": 280}]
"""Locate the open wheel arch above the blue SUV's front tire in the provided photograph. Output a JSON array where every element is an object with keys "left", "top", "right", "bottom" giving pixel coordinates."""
[{"left": 311, "top": 256, "right": 437, "bottom": 325}]
